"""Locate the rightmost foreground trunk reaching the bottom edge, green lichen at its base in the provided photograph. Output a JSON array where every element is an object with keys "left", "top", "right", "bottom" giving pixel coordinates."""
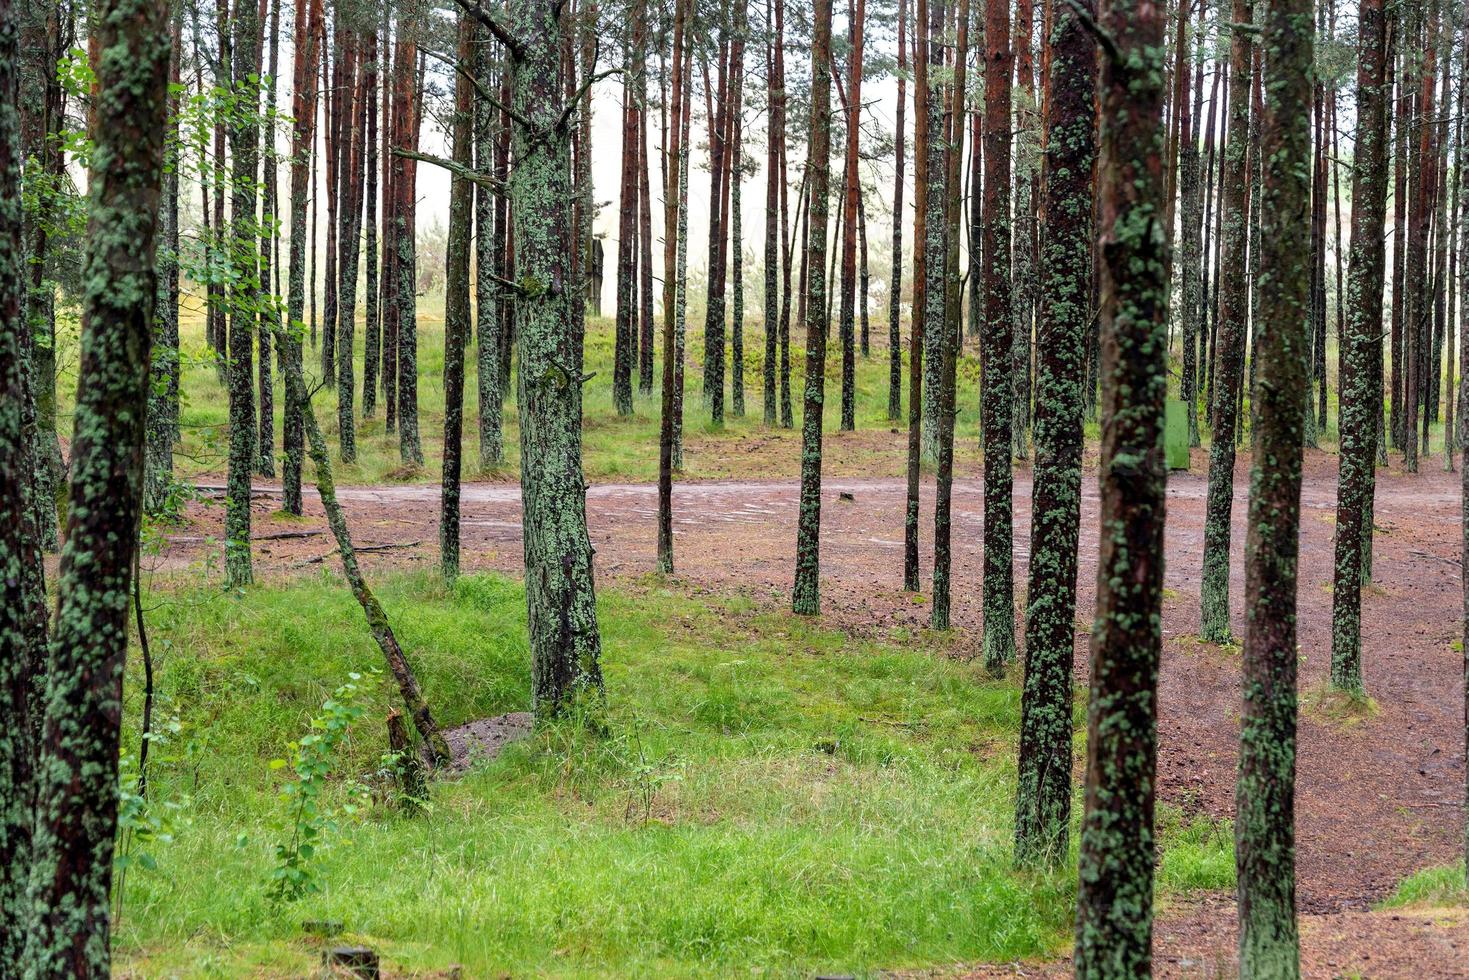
[{"left": 1234, "top": 0, "right": 1316, "bottom": 977}]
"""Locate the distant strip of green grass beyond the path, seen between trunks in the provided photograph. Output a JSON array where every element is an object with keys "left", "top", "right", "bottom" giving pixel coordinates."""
[{"left": 57, "top": 294, "right": 1386, "bottom": 483}]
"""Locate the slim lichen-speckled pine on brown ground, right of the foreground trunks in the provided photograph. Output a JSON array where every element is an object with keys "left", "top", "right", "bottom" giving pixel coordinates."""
[{"left": 1331, "top": 0, "right": 1393, "bottom": 692}]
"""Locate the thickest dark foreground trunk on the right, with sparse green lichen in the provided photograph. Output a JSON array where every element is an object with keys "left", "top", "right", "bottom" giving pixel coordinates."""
[{"left": 1075, "top": 0, "right": 1169, "bottom": 963}]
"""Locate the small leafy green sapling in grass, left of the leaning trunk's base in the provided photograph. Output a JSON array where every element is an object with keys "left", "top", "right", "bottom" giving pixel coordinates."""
[{"left": 269, "top": 673, "right": 366, "bottom": 902}]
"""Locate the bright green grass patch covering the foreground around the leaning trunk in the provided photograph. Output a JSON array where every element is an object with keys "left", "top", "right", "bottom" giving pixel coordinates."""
[{"left": 116, "top": 573, "right": 1232, "bottom": 977}]
